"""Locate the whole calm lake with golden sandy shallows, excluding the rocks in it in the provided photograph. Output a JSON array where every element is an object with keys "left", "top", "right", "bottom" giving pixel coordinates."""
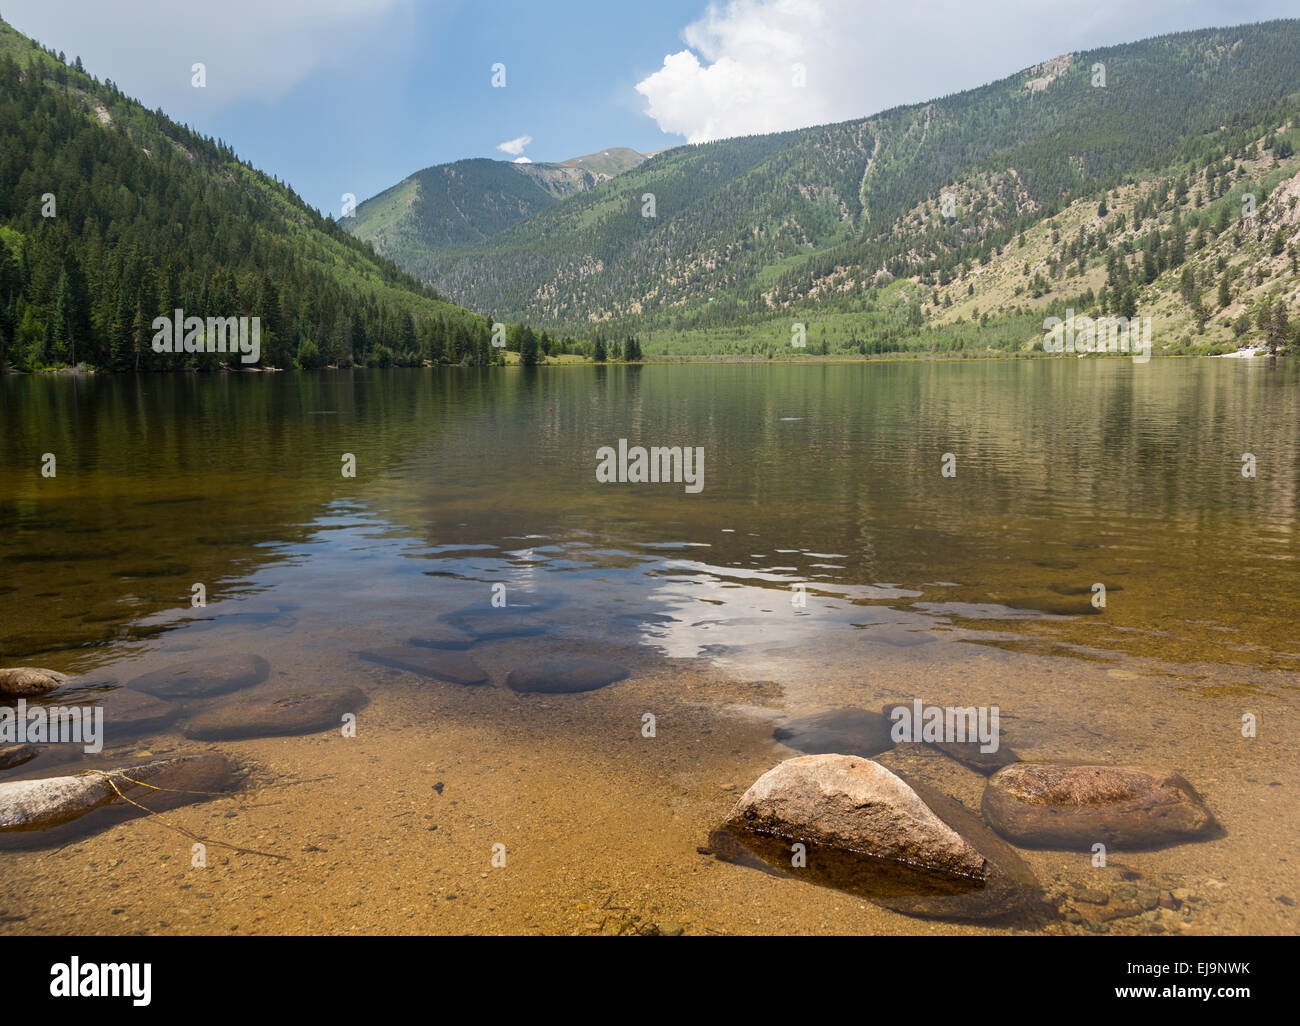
[{"left": 0, "top": 359, "right": 1300, "bottom": 934}]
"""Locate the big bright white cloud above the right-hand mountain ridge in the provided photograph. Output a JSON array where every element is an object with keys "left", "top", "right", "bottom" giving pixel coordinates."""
[{"left": 636, "top": 0, "right": 1294, "bottom": 143}]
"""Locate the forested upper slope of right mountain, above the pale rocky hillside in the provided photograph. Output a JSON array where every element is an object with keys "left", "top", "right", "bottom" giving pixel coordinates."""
[{"left": 402, "top": 21, "right": 1300, "bottom": 333}]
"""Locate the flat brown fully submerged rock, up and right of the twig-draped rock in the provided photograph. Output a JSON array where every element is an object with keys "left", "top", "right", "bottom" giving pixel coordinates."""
[{"left": 181, "top": 684, "right": 368, "bottom": 741}]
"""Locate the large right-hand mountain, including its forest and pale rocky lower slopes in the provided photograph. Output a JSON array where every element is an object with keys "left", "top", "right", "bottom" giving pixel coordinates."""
[{"left": 384, "top": 21, "right": 1300, "bottom": 352}]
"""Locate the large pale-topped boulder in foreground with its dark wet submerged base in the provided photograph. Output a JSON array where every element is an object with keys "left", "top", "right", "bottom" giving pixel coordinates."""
[{"left": 725, "top": 754, "right": 1037, "bottom": 919}]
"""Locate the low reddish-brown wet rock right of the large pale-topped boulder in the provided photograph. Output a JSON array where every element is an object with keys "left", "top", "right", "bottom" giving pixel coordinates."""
[{"left": 983, "top": 762, "right": 1219, "bottom": 850}]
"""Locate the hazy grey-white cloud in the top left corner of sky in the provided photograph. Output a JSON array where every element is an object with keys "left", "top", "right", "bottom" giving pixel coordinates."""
[{"left": 4, "top": 0, "right": 412, "bottom": 113}]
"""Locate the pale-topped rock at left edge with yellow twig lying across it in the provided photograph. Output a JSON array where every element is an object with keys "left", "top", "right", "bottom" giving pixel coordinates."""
[{"left": 0, "top": 756, "right": 231, "bottom": 835}]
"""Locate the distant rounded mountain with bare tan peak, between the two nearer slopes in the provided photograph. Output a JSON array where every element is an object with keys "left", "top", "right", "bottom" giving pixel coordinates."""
[{"left": 343, "top": 148, "right": 645, "bottom": 260}]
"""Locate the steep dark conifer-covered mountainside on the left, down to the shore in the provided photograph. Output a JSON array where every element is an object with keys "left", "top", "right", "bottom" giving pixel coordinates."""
[{"left": 0, "top": 22, "right": 506, "bottom": 371}]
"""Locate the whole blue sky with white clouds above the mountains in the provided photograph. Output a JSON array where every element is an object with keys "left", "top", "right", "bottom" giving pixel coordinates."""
[{"left": 10, "top": 0, "right": 1296, "bottom": 213}]
